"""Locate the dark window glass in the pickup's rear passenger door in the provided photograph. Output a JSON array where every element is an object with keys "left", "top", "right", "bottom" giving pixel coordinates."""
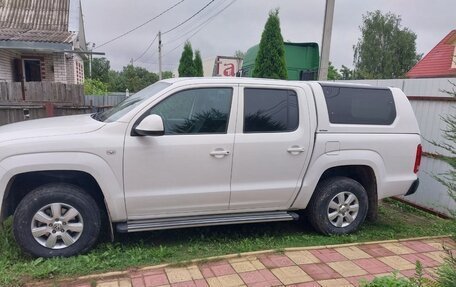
[{"left": 244, "top": 88, "right": 299, "bottom": 133}]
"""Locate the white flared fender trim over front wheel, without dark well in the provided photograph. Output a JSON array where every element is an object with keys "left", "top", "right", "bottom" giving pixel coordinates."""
[{"left": 0, "top": 152, "right": 127, "bottom": 222}]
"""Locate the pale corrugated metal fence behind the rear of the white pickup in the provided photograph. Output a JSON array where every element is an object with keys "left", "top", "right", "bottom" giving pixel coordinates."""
[{"left": 337, "top": 78, "right": 456, "bottom": 215}]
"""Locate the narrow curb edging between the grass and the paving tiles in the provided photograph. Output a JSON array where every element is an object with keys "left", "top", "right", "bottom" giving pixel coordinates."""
[{"left": 26, "top": 235, "right": 452, "bottom": 286}]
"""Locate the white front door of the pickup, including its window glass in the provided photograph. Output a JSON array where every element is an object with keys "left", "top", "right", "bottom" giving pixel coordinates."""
[{"left": 124, "top": 86, "right": 237, "bottom": 220}]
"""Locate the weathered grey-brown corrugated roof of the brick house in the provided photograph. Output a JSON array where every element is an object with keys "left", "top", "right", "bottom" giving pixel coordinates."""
[{"left": 0, "top": 0, "right": 80, "bottom": 43}]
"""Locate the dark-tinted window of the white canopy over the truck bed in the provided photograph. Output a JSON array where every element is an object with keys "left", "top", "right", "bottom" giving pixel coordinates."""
[{"left": 321, "top": 85, "right": 396, "bottom": 125}]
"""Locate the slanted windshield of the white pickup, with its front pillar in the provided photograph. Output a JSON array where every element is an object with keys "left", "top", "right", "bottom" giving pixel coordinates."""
[{"left": 92, "top": 82, "right": 171, "bottom": 122}]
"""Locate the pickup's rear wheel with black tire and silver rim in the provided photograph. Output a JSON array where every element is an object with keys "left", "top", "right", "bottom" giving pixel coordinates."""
[{"left": 307, "top": 177, "right": 369, "bottom": 235}]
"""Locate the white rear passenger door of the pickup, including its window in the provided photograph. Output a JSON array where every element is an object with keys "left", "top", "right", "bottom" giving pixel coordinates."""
[{"left": 230, "top": 85, "right": 312, "bottom": 210}]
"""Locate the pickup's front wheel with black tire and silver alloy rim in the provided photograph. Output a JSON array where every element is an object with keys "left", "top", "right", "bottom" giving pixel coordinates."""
[{"left": 13, "top": 183, "right": 101, "bottom": 258}]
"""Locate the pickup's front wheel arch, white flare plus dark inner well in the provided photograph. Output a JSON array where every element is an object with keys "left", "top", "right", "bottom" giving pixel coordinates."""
[{"left": 0, "top": 153, "right": 126, "bottom": 230}]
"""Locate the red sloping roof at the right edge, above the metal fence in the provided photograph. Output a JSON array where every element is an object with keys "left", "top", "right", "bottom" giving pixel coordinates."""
[{"left": 406, "top": 30, "right": 456, "bottom": 78}]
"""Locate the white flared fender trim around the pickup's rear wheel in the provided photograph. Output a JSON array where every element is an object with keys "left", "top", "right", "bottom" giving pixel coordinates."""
[{"left": 291, "top": 150, "right": 385, "bottom": 209}]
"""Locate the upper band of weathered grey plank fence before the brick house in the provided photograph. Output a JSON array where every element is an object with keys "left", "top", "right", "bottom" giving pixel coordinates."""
[{"left": 0, "top": 82, "right": 84, "bottom": 106}]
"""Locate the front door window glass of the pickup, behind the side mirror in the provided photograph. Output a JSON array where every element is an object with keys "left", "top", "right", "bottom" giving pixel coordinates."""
[{"left": 149, "top": 88, "right": 233, "bottom": 135}]
